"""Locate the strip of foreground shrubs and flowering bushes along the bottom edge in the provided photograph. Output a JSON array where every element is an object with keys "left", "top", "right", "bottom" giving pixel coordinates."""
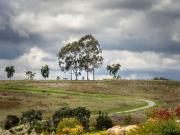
[{"left": 0, "top": 107, "right": 180, "bottom": 135}]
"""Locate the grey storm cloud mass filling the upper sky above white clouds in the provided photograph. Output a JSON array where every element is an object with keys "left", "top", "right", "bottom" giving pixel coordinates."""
[{"left": 0, "top": 0, "right": 180, "bottom": 59}]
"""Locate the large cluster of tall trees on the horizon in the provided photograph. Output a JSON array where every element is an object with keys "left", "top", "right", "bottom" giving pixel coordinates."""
[{"left": 58, "top": 35, "right": 103, "bottom": 80}]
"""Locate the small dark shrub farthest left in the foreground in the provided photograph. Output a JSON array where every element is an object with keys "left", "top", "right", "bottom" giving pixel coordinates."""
[{"left": 4, "top": 115, "right": 19, "bottom": 130}]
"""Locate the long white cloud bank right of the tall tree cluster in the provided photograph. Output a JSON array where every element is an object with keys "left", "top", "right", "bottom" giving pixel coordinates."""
[{"left": 103, "top": 51, "right": 180, "bottom": 72}]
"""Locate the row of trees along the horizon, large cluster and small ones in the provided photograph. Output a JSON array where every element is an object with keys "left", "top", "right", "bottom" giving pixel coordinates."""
[{"left": 5, "top": 35, "right": 121, "bottom": 80}]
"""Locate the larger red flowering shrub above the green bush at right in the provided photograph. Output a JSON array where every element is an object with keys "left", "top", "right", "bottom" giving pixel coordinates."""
[{"left": 152, "top": 109, "right": 173, "bottom": 120}]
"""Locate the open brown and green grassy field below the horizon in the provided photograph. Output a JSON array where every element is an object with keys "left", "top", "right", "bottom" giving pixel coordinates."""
[{"left": 0, "top": 80, "right": 180, "bottom": 125}]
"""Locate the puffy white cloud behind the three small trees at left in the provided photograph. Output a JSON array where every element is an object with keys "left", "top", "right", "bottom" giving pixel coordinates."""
[{"left": 0, "top": 47, "right": 58, "bottom": 79}]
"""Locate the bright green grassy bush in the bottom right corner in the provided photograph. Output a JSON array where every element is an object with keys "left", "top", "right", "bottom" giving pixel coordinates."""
[{"left": 128, "top": 120, "right": 180, "bottom": 135}]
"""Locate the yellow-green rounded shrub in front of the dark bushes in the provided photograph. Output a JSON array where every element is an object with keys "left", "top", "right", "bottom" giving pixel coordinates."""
[{"left": 56, "top": 118, "right": 83, "bottom": 135}]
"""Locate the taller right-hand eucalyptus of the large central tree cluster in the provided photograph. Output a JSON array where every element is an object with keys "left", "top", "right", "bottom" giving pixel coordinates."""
[{"left": 79, "top": 35, "right": 103, "bottom": 80}]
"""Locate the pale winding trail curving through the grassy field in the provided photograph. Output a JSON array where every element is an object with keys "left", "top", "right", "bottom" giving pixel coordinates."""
[{"left": 93, "top": 99, "right": 156, "bottom": 117}]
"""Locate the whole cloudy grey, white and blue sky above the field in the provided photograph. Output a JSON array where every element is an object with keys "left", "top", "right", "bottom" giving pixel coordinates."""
[{"left": 0, "top": 0, "right": 180, "bottom": 79}]
